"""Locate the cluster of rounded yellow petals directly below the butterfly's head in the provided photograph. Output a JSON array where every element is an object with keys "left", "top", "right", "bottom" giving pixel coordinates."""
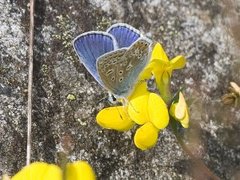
[{"left": 96, "top": 82, "right": 169, "bottom": 150}]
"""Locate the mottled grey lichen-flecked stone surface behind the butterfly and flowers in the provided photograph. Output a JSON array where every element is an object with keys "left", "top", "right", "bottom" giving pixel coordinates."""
[{"left": 0, "top": 0, "right": 240, "bottom": 179}]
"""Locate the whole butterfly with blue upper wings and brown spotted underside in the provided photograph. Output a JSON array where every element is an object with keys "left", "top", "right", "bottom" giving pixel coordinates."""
[{"left": 73, "top": 23, "right": 152, "bottom": 98}]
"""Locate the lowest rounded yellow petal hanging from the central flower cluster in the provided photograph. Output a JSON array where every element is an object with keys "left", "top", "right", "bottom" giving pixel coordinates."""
[{"left": 134, "top": 122, "right": 158, "bottom": 150}]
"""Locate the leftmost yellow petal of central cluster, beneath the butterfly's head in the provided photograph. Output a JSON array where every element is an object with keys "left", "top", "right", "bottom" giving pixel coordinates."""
[{"left": 96, "top": 106, "right": 134, "bottom": 131}]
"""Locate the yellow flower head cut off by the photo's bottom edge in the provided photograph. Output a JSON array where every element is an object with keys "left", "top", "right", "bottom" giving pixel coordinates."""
[{"left": 12, "top": 161, "right": 96, "bottom": 180}]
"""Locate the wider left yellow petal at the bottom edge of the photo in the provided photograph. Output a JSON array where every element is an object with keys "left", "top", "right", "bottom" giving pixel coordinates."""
[{"left": 12, "top": 162, "right": 62, "bottom": 180}]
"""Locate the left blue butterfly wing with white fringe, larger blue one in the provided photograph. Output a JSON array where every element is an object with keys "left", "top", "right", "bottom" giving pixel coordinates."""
[{"left": 73, "top": 31, "right": 117, "bottom": 86}]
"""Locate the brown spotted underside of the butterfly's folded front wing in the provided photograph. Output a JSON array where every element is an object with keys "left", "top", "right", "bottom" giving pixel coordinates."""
[{"left": 97, "top": 38, "right": 151, "bottom": 97}]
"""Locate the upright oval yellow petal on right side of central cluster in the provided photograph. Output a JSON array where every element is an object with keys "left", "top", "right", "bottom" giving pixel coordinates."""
[{"left": 148, "top": 93, "right": 169, "bottom": 129}]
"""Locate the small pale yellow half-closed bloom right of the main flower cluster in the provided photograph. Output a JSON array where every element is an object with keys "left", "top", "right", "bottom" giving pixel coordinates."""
[{"left": 170, "top": 92, "right": 189, "bottom": 128}]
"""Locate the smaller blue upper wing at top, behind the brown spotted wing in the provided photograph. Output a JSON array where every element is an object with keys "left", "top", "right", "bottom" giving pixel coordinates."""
[{"left": 107, "top": 23, "right": 142, "bottom": 48}]
